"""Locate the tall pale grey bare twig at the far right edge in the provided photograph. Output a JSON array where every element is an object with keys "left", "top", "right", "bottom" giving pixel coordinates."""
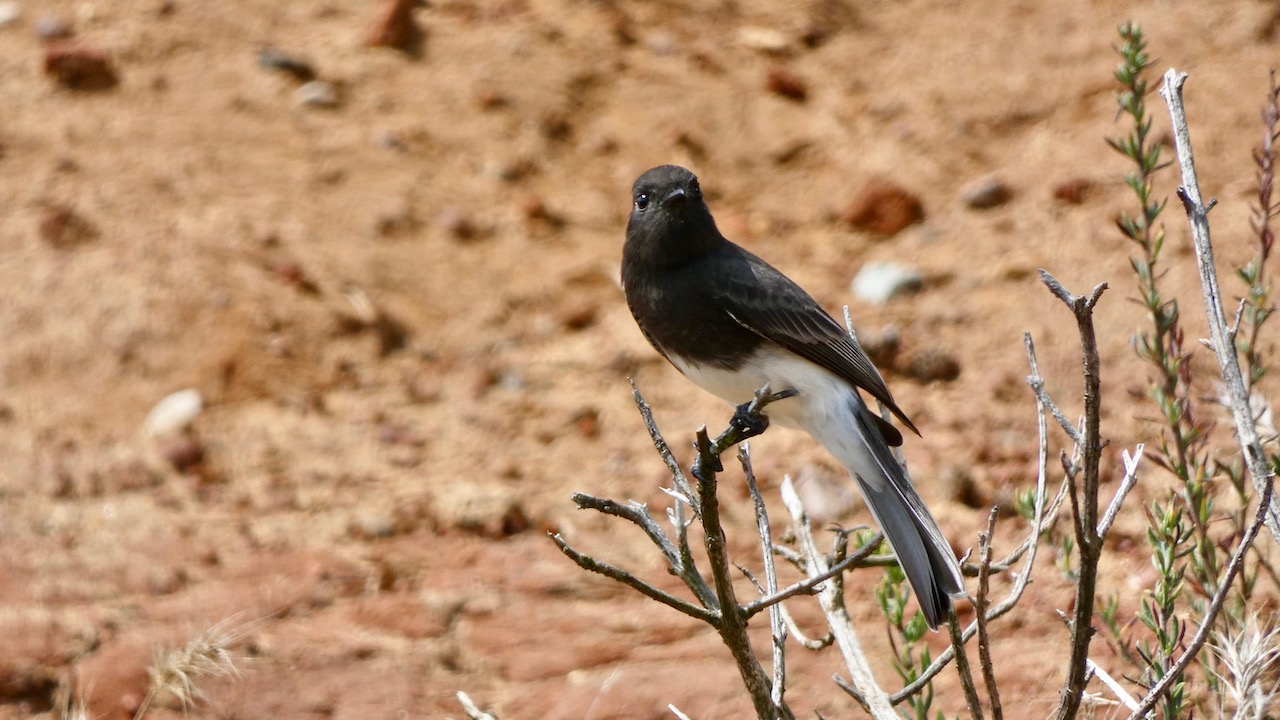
[{"left": 1160, "top": 68, "right": 1280, "bottom": 542}]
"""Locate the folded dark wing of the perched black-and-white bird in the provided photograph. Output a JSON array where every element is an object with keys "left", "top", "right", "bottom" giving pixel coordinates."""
[{"left": 712, "top": 246, "right": 920, "bottom": 446}]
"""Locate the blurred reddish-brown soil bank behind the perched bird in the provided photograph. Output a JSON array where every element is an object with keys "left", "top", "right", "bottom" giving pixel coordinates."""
[{"left": 0, "top": 0, "right": 1276, "bottom": 720}]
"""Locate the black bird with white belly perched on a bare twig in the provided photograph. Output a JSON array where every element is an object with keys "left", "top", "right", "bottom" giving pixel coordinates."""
[{"left": 622, "top": 165, "right": 964, "bottom": 628}]
